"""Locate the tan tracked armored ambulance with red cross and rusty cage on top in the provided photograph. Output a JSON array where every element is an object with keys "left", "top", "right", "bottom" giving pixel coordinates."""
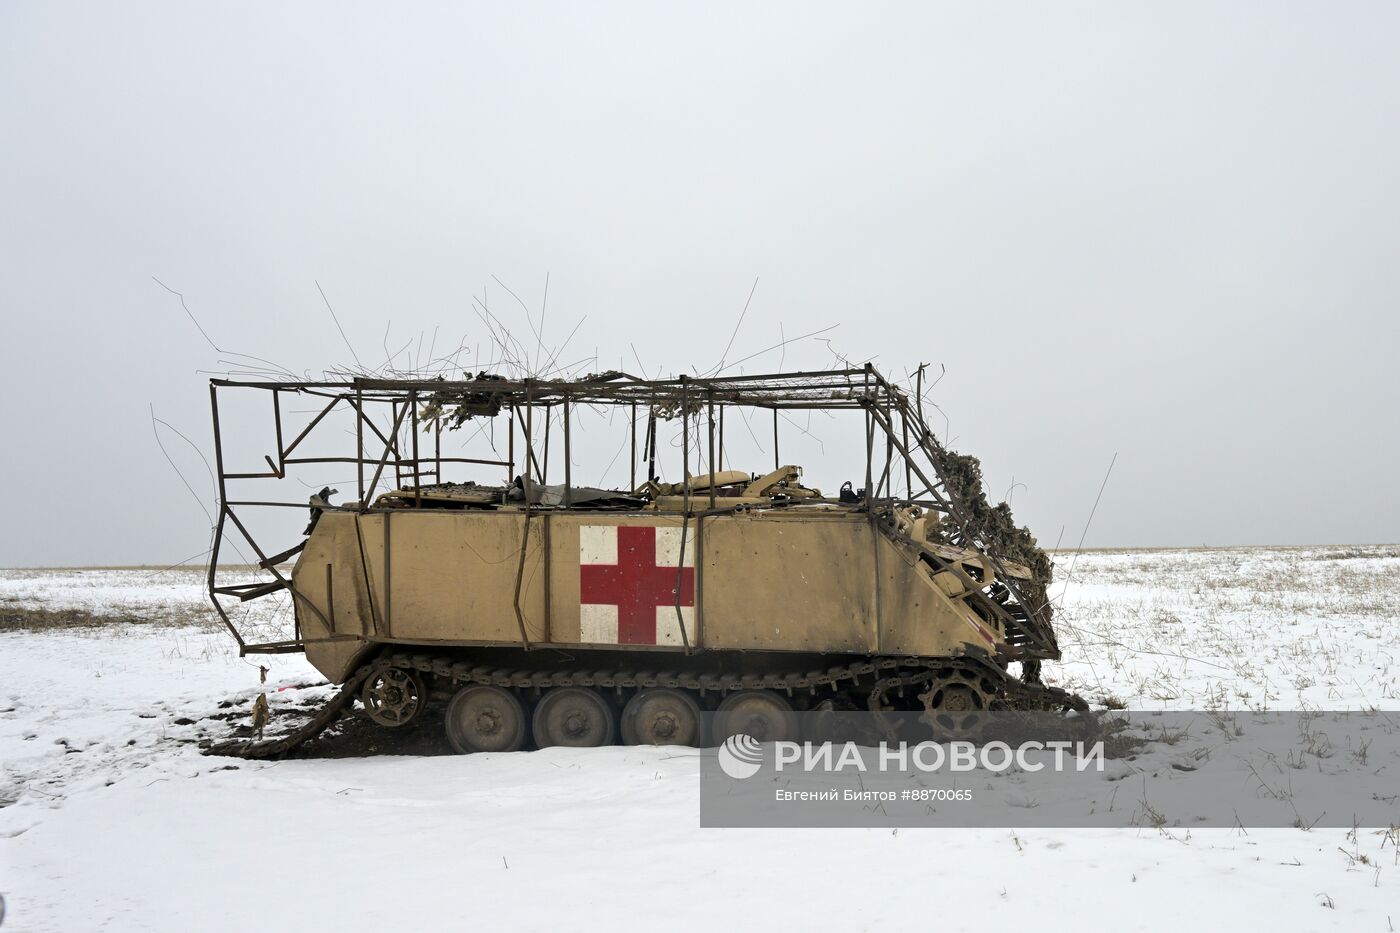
[{"left": 209, "top": 366, "right": 1085, "bottom": 755}]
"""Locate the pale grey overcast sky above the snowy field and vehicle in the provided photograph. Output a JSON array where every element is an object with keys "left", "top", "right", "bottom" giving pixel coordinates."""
[{"left": 0, "top": 1, "right": 1400, "bottom": 566}]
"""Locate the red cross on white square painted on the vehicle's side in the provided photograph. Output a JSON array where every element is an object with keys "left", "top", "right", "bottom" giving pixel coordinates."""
[{"left": 578, "top": 525, "right": 696, "bottom": 644}]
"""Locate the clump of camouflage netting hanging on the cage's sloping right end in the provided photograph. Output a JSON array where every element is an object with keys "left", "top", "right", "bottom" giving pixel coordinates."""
[{"left": 937, "top": 447, "right": 1053, "bottom": 619}]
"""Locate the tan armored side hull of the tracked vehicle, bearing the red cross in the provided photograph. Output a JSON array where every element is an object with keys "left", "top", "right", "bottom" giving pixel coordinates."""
[{"left": 293, "top": 507, "right": 1004, "bottom": 681}]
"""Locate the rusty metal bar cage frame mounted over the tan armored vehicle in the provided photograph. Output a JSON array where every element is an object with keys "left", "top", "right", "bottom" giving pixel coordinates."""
[{"left": 207, "top": 364, "right": 1060, "bottom": 660}]
